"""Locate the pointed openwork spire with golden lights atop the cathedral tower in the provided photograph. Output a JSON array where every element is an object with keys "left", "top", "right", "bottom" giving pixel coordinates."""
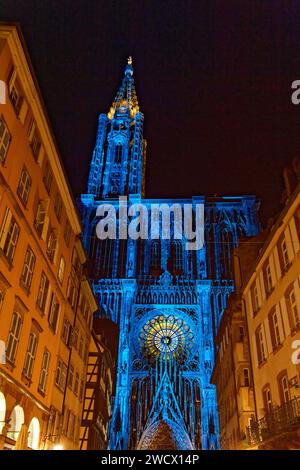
[{"left": 107, "top": 56, "right": 139, "bottom": 120}]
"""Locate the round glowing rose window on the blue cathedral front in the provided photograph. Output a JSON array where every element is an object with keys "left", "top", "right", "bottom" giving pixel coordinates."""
[{"left": 139, "top": 315, "right": 194, "bottom": 359}]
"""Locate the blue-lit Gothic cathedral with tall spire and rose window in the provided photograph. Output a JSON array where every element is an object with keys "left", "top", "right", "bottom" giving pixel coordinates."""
[{"left": 80, "top": 58, "right": 259, "bottom": 450}]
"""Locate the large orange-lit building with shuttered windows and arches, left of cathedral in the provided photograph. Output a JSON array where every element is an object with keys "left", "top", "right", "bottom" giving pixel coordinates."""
[{"left": 0, "top": 24, "right": 97, "bottom": 449}]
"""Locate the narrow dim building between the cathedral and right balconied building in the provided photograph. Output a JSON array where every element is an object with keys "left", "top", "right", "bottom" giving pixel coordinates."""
[{"left": 212, "top": 295, "right": 255, "bottom": 450}]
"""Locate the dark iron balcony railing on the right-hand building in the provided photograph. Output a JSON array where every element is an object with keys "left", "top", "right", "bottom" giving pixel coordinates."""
[{"left": 247, "top": 397, "right": 300, "bottom": 445}]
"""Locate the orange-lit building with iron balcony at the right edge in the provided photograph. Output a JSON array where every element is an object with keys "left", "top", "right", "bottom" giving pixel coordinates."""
[{"left": 242, "top": 168, "right": 300, "bottom": 448}]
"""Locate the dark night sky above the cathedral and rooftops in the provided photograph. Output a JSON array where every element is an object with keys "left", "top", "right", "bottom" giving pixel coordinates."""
[{"left": 0, "top": 0, "right": 300, "bottom": 223}]
